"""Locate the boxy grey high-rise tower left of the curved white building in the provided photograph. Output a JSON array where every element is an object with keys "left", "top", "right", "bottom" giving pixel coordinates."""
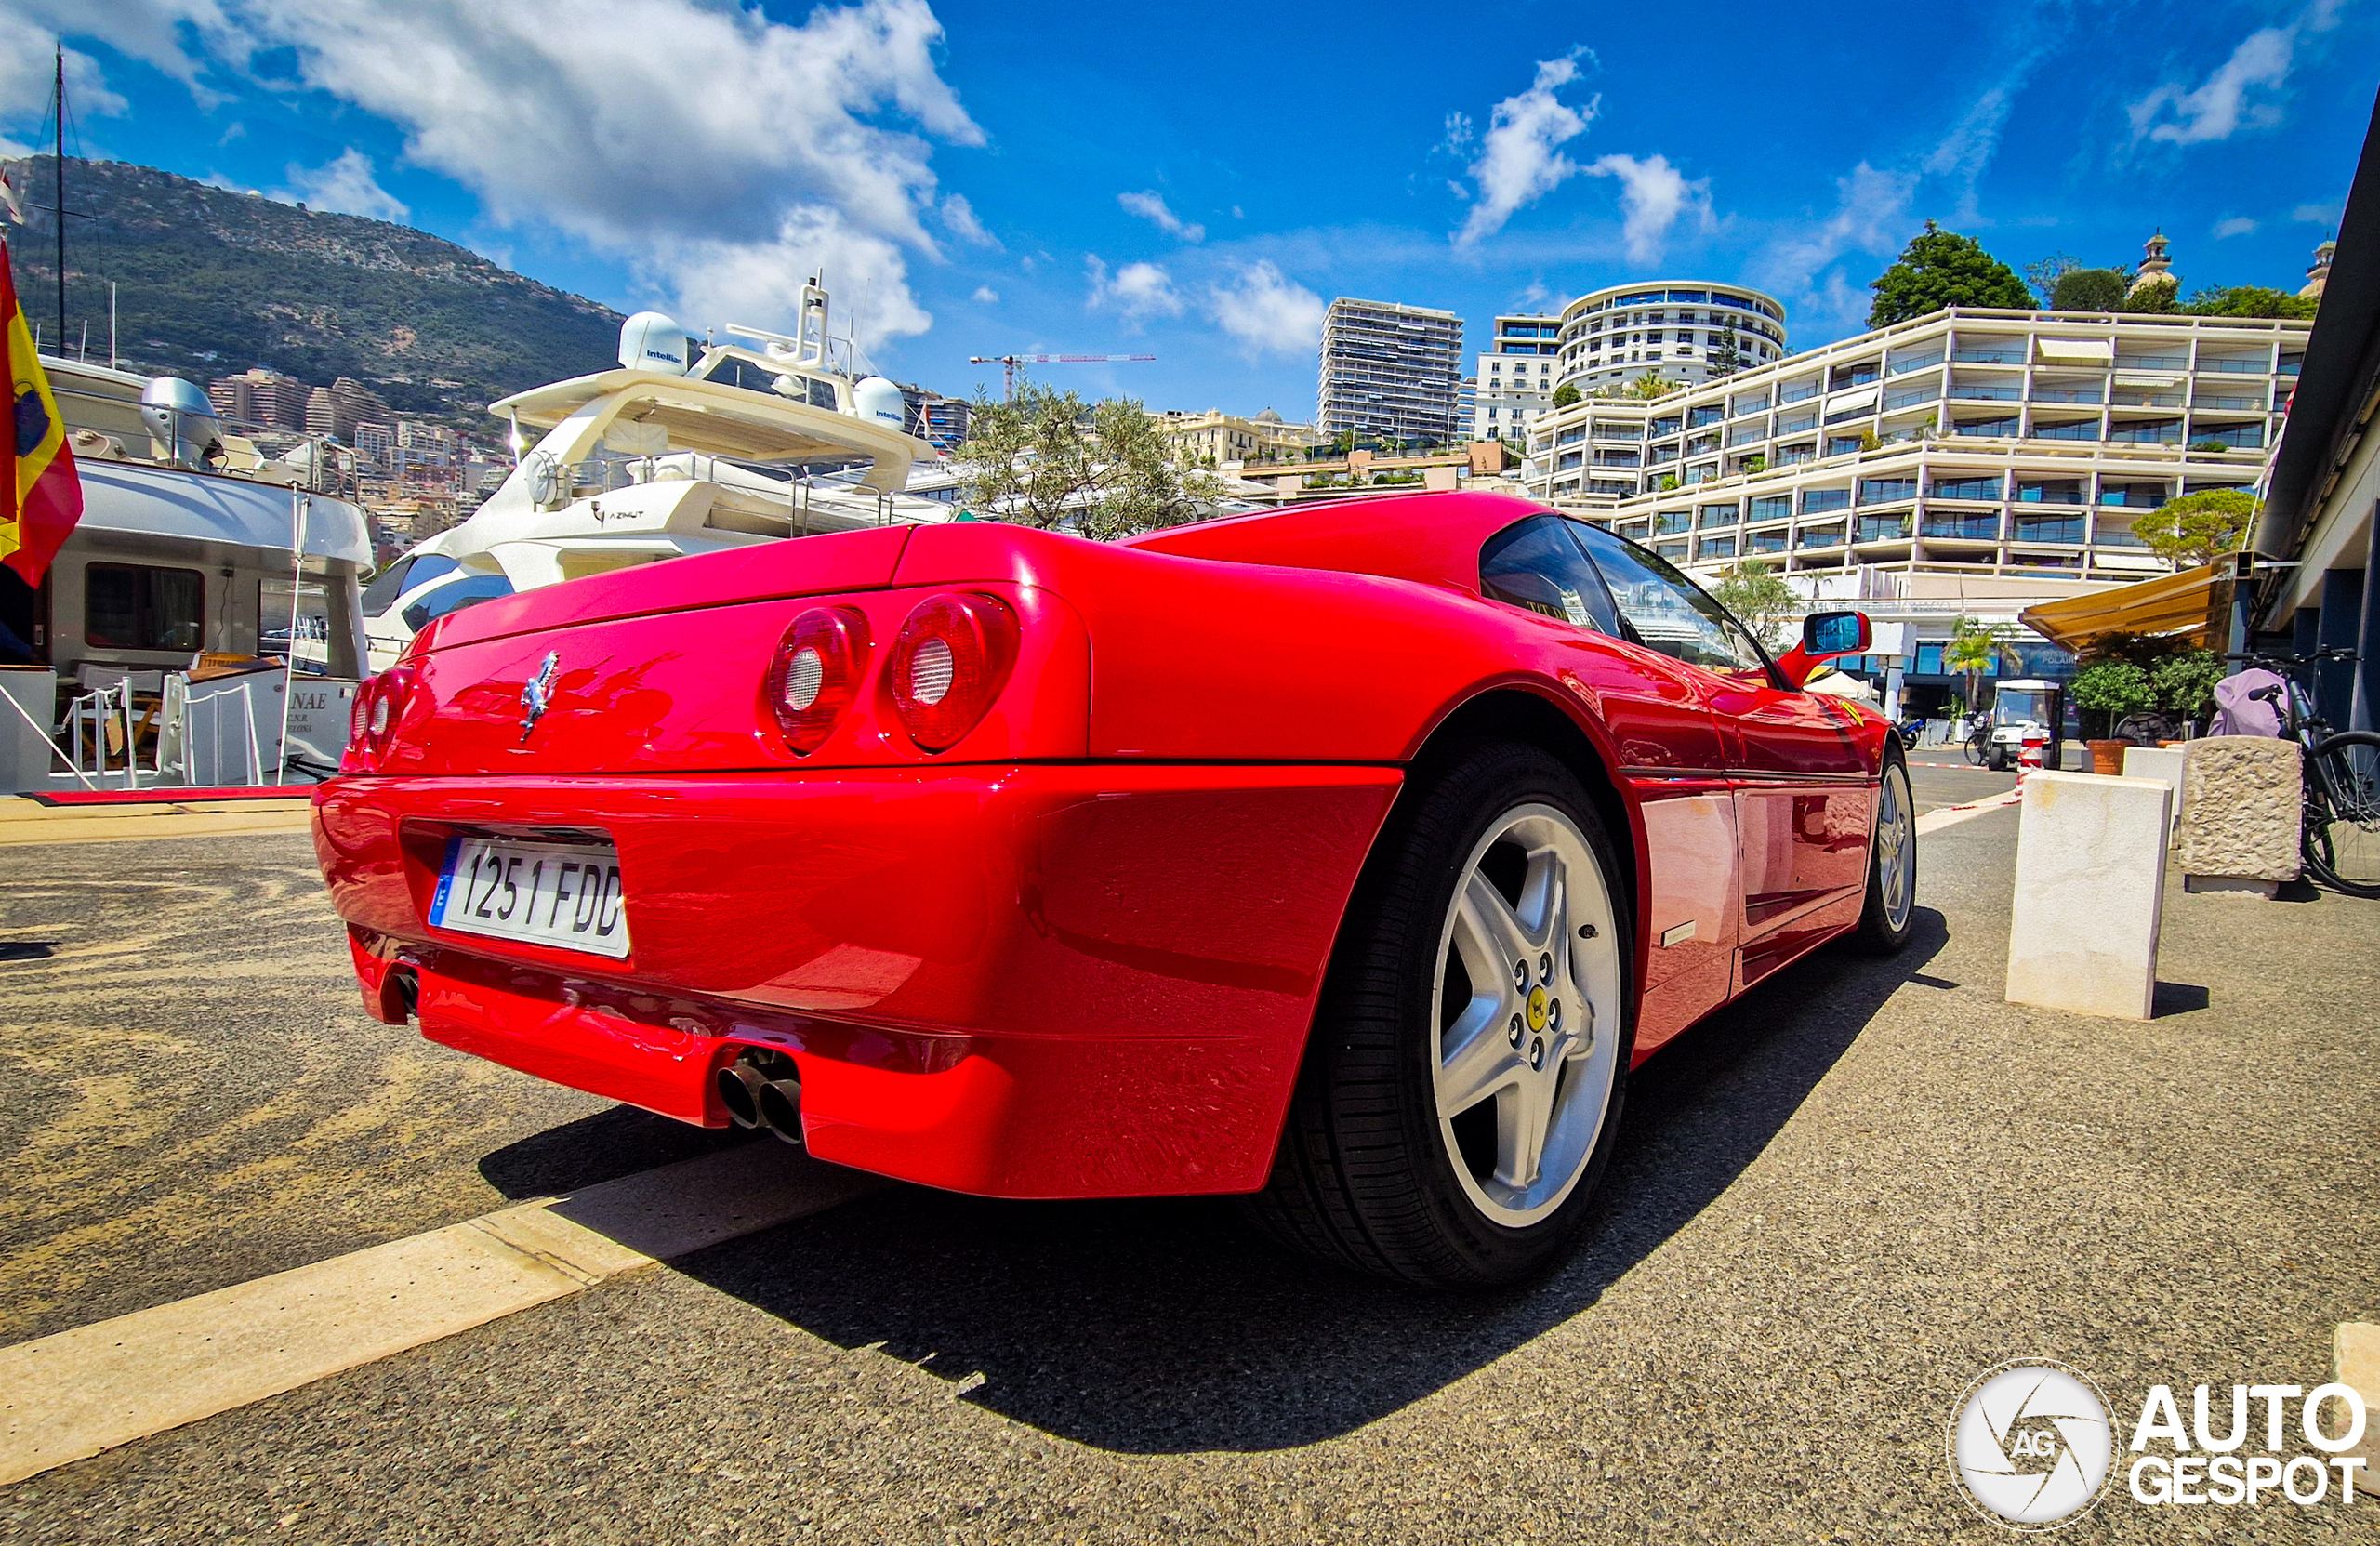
[{"left": 1314, "top": 295, "right": 1466, "bottom": 444}]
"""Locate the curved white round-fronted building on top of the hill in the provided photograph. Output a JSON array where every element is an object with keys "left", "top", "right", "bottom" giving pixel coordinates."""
[{"left": 1554, "top": 278, "right": 1785, "bottom": 392}]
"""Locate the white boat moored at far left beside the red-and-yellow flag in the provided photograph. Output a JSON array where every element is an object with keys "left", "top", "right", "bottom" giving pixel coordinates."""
[{"left": 0, "top": 354, "right": 371, "bottom": 792}]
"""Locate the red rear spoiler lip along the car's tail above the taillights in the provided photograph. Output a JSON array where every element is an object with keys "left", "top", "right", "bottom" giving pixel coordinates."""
[{"left": 404, "top": 525, "right": 923, "bottom": 659}]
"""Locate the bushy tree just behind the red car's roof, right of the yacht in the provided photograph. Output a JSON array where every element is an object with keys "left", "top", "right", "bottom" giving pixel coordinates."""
[{"left": 961, "top": 380, "right": 1223, "bottom": 540}]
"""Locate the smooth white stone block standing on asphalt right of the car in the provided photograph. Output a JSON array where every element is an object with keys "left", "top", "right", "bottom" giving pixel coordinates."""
[{"left": 2006, "top": 773, "right": 2173, "bottom": 1021}]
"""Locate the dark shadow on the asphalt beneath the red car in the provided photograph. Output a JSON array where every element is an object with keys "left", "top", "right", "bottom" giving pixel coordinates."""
[{"left": 632, "top": 908, "right": 1947, "bottom": 1453}]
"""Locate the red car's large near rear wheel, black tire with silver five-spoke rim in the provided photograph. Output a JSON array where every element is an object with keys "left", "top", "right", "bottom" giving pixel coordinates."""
[{"left": 1252, "top": 745, "right": 1633, "bottom": 1287}]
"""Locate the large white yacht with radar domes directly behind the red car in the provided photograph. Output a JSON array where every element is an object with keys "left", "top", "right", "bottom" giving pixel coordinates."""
[{"left": 364, "top": 281, "right": 957, "bottom": 670}]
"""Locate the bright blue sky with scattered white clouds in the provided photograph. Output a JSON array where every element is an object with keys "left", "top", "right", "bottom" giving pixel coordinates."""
[{"left": 0, "top": 0, "right": 2380, "bottom": 418}]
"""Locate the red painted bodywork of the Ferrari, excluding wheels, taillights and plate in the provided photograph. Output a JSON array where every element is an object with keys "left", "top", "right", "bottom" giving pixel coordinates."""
[{"left": 314, "top": 495, "right": 1885, "bottom": 1196}]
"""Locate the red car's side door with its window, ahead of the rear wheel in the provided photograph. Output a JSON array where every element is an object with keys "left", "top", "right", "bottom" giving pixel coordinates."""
[{"left": 1590, "top": 533, "right": 1875, "bottom": 989}]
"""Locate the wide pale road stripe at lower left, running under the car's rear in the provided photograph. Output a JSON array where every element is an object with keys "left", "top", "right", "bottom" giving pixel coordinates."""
[{"left": 0, "top": 1144, "right": 885, "bottom": 1484}]
